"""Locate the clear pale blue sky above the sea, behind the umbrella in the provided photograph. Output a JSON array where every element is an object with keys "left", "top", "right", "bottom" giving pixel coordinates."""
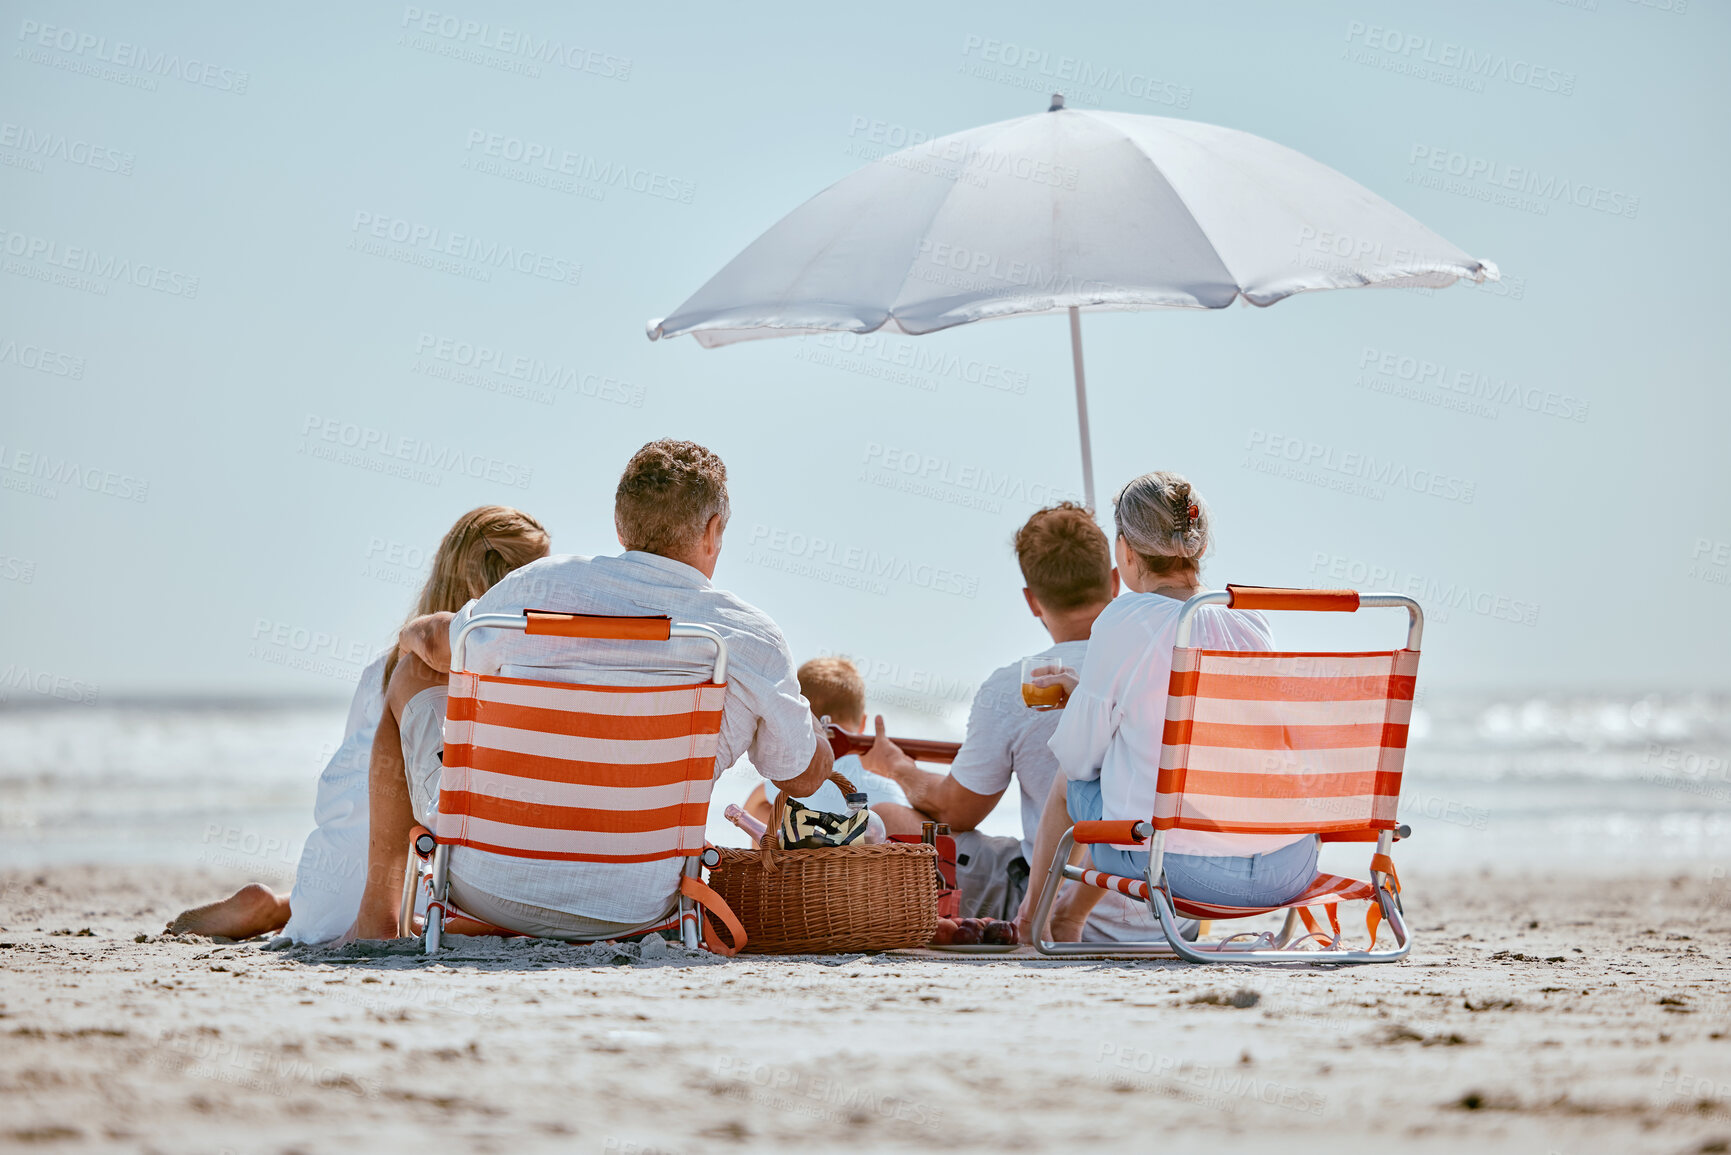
[{"left": 0, "top": 0, "right": 1731, "bottom": 701}]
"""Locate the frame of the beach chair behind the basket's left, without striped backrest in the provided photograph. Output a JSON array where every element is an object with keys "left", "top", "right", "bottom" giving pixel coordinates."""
[{"left": 398, "top": 610, "right": 744, "bottom": 954}]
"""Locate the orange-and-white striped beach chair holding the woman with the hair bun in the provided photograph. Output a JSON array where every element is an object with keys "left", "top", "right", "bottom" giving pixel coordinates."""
[{"left": 1033, "top": 585, "right": 1425, "bottom": 963}]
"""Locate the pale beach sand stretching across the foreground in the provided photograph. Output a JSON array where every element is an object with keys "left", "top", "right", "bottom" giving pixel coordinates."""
[{"left": 0, "top": 868, "right": 1731, "bottom": 1155}]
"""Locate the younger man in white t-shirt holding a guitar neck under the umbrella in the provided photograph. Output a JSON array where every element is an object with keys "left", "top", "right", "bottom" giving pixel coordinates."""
[{"left": 864, "top": 502, "right": 1184, "bottom": 940}]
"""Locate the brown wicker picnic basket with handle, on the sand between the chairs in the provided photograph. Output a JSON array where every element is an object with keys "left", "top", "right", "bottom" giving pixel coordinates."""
[{"left": 710, "top": 771, "right": 938, "bottom": 954}]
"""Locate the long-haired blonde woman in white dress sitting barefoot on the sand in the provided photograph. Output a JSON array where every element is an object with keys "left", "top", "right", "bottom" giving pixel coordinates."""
[{"left": 168, "top": 506, "right": 549, "bottom": 942}]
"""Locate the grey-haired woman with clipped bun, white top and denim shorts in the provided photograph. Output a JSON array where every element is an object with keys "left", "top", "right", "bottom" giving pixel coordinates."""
[{"left": 1023, "top": 471, "right": 1317, "bottom": 939}]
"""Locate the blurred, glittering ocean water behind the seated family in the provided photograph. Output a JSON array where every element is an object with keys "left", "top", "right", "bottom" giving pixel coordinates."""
[{"left": 0, "top": 694, "right": 1731, "bottom": 888}]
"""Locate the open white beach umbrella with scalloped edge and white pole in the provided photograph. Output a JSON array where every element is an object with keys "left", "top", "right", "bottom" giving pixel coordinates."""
[{"left": 649, "top": 95, "right": 1497, "bottom": 507}]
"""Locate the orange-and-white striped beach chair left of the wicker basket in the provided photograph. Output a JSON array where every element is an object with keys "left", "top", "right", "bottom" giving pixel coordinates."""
[{"left": 400, "top": 610, "right": 744, "bottom": 954}]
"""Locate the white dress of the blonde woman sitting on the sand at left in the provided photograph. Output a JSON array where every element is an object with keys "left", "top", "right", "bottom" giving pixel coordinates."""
[{"left": 282, "top": 653, "right": 388, "bottom": 942}]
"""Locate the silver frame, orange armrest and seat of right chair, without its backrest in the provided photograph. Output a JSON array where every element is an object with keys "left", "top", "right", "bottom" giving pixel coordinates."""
[{"left": 1033, "top": 585, "right": 1425, "bottom": 963}]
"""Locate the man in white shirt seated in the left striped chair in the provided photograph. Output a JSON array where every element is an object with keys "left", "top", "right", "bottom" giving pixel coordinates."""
[{"left": 358, "top": 440, "right": 831, "bottom": 939}]
